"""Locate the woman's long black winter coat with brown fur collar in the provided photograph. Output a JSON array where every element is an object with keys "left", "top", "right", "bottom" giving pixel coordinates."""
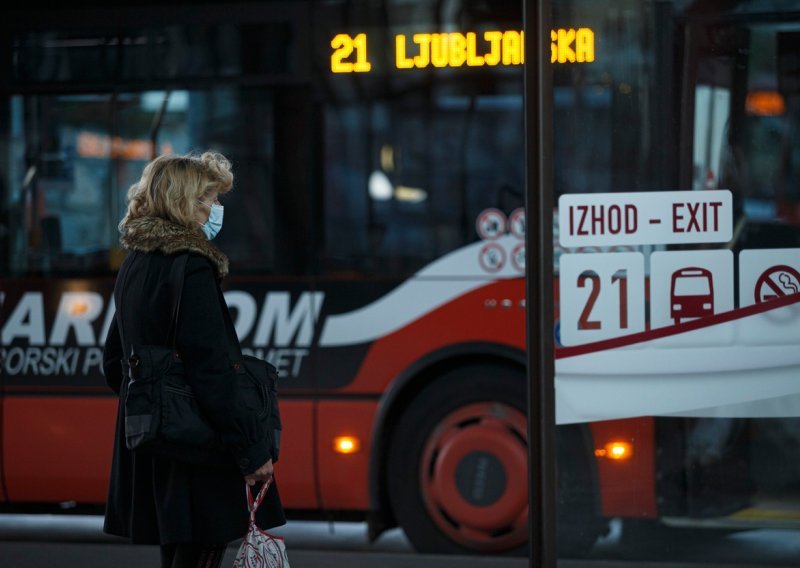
[{"left": 103, "top": 218, "right": 286, "bottom": 544}]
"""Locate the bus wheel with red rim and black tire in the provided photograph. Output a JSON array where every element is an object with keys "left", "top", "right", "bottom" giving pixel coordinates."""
[{"left": 387, "top": 365, "right": 528, "bottom": 554}]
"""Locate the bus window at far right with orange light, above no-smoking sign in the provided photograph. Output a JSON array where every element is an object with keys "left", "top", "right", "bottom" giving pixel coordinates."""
[{"left": 683, "top": 21, "right": 800, "bottom": 250}]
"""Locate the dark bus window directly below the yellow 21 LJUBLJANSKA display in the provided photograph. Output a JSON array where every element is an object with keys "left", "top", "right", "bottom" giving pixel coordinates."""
[{"left": 322, "top": 93, "right": 524, "bottom": 276}]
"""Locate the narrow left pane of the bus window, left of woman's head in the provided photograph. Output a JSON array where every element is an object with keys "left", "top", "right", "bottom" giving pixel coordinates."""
[{"left": 7, "top": 95, "right": 123, "bottom": 272}]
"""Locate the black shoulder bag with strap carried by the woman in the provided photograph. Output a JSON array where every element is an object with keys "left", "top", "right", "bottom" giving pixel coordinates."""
[{"left": 117, "top": 254, "right": 281, "bottom": 465}]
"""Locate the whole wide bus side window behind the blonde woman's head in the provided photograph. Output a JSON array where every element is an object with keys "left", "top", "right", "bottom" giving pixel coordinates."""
[{"left": 6, "top": 87, "right": 310, "bottom": 273}]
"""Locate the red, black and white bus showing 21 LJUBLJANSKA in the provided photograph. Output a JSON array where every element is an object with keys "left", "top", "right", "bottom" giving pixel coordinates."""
[{"left": 0, "top": 0, "right": 800, "bottom": 555}]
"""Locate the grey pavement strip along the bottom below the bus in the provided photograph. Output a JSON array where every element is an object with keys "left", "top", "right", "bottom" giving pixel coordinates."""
[{"left": 0, "top": 515, "right": 800, "bottom": 568}]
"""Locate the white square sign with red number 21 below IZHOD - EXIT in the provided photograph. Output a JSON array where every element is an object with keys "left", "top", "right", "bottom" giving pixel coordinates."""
[{"left": 559, "top": 252, "right": 645, "bottom": 346}]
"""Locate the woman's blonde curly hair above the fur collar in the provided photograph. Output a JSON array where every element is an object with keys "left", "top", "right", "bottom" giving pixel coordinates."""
[{"left": 119, "top": 152, "right": 233, "bottom": 234}]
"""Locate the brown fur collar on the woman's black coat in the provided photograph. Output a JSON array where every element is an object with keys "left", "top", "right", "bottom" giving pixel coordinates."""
[{"left": 120, "top": 217, "right": 228, "bottom": 278}]
